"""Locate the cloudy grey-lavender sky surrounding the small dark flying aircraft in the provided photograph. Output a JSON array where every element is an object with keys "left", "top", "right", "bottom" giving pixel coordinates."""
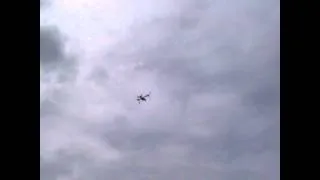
[{"left": 40, "top": 0, "right": 280, "bottom": 180}]
